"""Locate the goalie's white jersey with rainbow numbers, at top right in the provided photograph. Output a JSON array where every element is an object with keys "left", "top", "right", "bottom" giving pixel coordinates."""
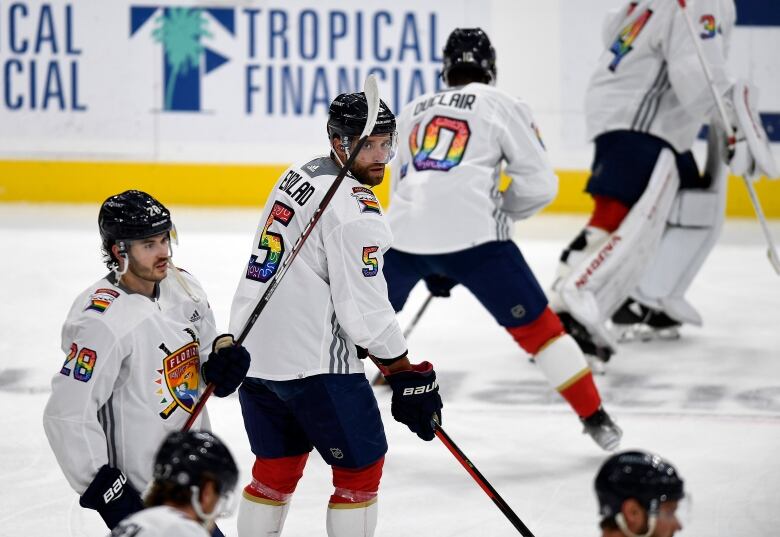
[{"left": 585, "top": 0, "right": 736, "bottom": 152}]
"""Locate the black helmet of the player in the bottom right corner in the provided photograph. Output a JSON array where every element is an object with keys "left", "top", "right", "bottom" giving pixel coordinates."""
[{"left": 595, "top": 451, "right": 685, "bottom": 519}]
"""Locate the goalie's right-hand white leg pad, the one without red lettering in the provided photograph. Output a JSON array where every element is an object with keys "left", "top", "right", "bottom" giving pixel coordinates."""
[{"left": 631, "top": 129, "right": 728, "bottom": 326}]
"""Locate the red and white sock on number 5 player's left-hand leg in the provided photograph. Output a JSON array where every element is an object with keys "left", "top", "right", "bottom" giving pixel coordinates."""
[{"left": 238, "top": 453, "right": 309, "bottom": 537}]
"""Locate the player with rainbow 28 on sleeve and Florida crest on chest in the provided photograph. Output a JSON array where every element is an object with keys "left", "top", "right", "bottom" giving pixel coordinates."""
[{"left": 43, "top": 190, "right": 249, "bottom": 528}]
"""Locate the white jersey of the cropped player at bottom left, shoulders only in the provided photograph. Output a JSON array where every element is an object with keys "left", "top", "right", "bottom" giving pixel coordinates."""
[{"left": 107, "top": 505, "right": 211, "bottom": 537}]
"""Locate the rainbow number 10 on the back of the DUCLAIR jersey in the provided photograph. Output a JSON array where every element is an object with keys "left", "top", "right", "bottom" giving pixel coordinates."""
[{"left": 409, "top": 116, "right": 471, "bottom": 172}]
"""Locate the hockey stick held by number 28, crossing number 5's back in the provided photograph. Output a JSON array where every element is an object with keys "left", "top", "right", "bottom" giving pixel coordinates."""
[{"left": 182, "top": 75, "right": 379, "bottom": 431}]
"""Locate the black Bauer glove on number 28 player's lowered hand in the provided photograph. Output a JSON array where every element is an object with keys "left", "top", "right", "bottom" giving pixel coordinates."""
[{"left": 79, "top": 464, "right": 144, "bottom": 529}]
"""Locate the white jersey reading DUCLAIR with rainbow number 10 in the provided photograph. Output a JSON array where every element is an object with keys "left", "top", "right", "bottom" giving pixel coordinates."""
[{"left": 388, "top": 83, "right": 558, "bottom": 254}]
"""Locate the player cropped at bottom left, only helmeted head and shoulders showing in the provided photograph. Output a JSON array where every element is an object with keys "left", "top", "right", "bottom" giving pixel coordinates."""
[{"left": 110, "top": 431, "right": 238, "bottom": 537}]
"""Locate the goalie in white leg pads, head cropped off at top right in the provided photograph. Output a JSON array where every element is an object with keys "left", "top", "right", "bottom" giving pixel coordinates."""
[{"left": 551, "top": 0, "right": 774, "bottom": 361}]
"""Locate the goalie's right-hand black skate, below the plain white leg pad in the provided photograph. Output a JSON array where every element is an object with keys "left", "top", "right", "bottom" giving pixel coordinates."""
[{"left": 612, "top": 298, "right": 682, "bottom": 343}]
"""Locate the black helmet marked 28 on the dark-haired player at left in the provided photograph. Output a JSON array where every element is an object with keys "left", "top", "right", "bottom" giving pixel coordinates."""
[{"left": 98, "top": 190, "right": 173, "bottom": 244}]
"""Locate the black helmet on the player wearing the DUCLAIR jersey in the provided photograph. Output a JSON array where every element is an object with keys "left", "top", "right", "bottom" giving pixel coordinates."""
[{"left": 441, "top": 28, "right": 496, "bottom": 84}]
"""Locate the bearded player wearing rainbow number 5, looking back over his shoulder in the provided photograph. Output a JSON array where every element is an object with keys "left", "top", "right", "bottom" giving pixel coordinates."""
[{"left": 230, "top": 93, "right": 442, "bottom": 537}]
